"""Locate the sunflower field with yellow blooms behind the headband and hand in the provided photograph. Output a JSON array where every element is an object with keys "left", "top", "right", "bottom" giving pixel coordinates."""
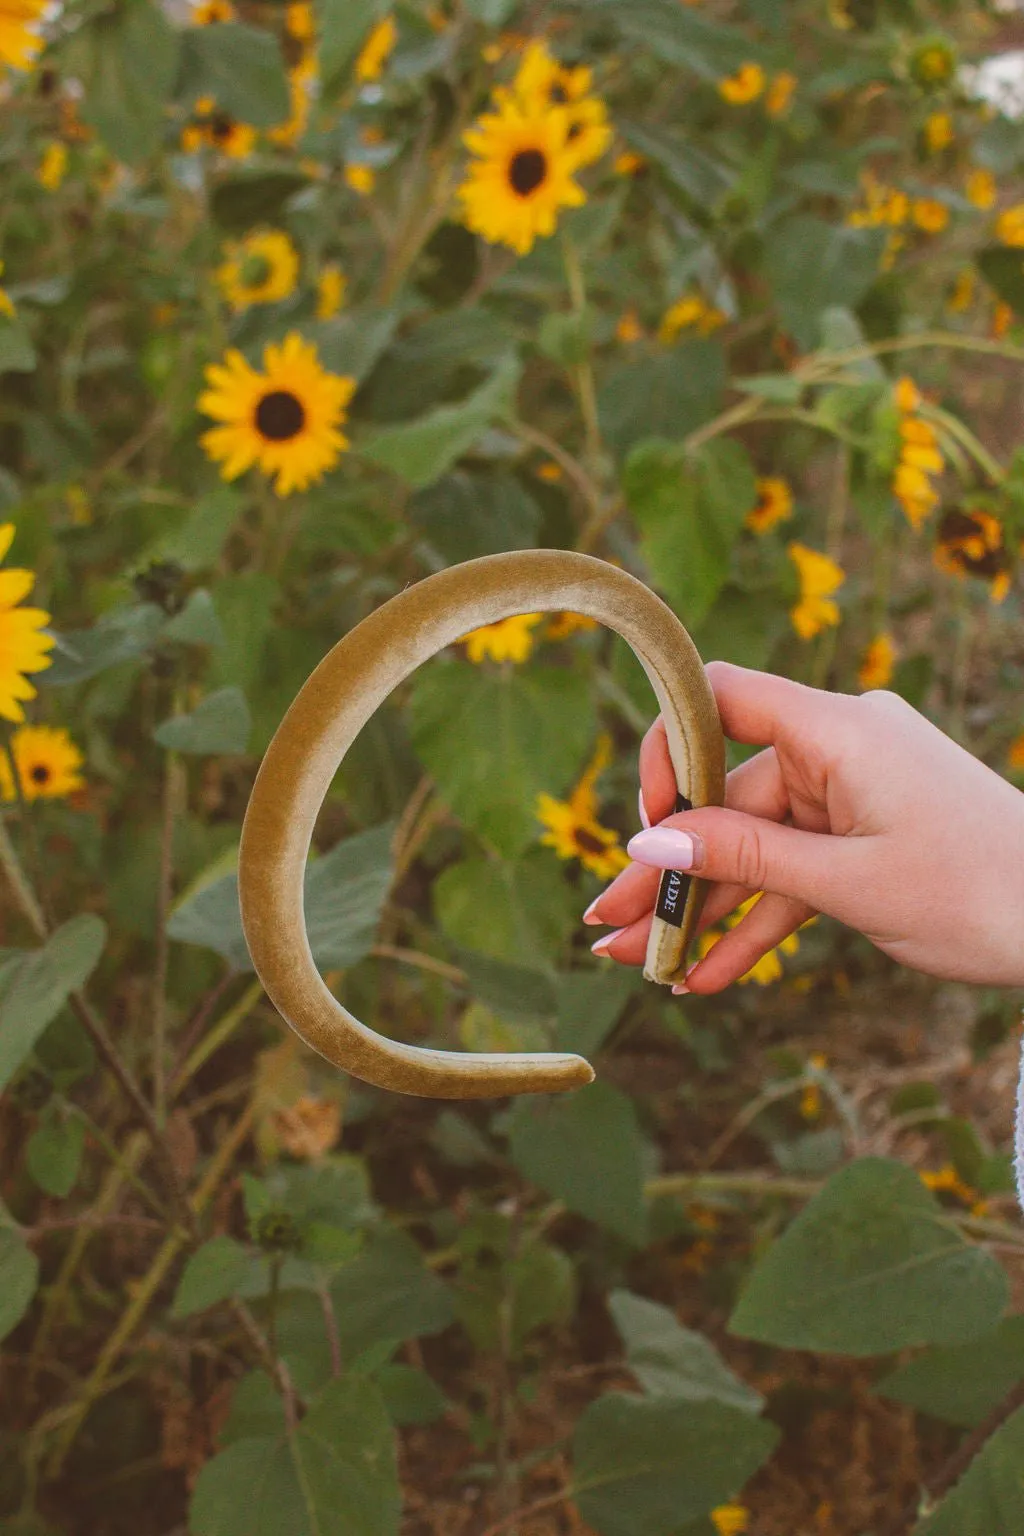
[{"left": 0, "top": 0, "right": 1024, "bottom": 1536}]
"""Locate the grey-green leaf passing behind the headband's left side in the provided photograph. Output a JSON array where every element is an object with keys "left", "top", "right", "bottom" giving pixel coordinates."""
[{"left": 167, "top": 822, "right": 395, "bottom": 971}]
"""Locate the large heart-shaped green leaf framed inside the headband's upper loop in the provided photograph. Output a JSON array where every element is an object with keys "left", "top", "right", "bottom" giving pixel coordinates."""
[{"left": 410, "top": 657, "right": 597, "bottom": 859}]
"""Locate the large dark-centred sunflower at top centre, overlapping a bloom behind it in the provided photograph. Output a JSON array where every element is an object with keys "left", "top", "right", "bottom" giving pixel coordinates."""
[{"left": 457, "top": 95, "right": 586, "bottom": 257}]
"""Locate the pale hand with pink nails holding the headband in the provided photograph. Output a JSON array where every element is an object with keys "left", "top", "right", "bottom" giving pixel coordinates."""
[{"left": 585, "top": 662, "right": 1024, "bottom": 995}]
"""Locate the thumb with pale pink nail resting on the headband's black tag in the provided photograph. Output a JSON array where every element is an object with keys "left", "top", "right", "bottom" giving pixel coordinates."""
[{"left": 626, "top": 805, "right": 863, "bottom": 917}]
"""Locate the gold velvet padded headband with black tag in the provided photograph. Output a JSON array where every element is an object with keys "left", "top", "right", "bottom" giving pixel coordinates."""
[{"left": 238, "top": 550, "right": 725, "bottom": 1098}]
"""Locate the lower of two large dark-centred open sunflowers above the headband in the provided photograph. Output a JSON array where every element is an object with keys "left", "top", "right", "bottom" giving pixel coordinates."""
[{"left": 197, "top": 330, "right": 356, "bottom": 496}]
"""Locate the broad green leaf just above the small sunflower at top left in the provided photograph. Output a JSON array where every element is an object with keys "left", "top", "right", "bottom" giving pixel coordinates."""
[{"left": 178, "top": 22, "right": 290, "bottom": 127}]
